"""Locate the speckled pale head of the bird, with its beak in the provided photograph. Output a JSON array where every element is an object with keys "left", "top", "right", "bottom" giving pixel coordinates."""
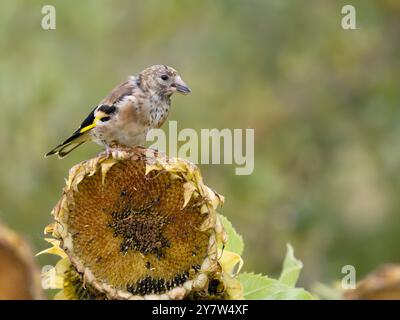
[{"left": 139, "top": 65, "right": 191, "bottom": 97}]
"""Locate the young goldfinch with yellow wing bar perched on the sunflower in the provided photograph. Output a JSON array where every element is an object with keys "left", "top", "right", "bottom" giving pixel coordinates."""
[{"left": 46, "top": 65, "right": 190, "bottom": 158}]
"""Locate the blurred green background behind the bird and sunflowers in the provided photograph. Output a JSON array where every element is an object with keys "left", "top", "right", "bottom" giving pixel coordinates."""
[{"left": 0, "top": 0, "right": 400, "bottom": 287}]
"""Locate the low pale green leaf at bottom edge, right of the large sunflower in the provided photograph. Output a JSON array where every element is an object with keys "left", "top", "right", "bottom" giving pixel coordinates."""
[{"left": 238, "top": 273, "right": 314, "bottom": 300}]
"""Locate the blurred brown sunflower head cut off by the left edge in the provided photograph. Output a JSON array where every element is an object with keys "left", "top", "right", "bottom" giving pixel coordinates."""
[{"left": 0, "top": 225, "right": 43, "bottom": 300}]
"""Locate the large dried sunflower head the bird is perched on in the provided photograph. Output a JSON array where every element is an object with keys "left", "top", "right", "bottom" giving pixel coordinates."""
[{"left": 46, "top": 148, "right": 239, "bottom": 299}]
